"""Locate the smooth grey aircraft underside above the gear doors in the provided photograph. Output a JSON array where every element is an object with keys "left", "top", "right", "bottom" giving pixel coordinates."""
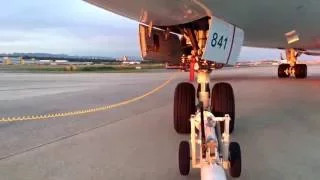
[{"left": 86, "top": 0, "right": 320, "bottom": 49}]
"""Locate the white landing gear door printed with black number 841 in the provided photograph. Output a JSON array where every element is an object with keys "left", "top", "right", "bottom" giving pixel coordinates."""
[{"left": 202, "top": 17, "right": 244, "bottom": 65}]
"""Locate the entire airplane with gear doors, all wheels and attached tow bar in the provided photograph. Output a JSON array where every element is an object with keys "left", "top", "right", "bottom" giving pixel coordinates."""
[{"left": 86, "top": 0, "right": 320, "bottom": 180}]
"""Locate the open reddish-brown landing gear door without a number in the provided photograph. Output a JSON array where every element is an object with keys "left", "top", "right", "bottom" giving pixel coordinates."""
[{"left": 139, "top": 24, "right": 182, "bottom": 63}]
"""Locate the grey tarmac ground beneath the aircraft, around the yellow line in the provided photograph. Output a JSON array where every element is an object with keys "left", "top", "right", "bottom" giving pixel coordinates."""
[{"left": 0, "top": 66, "right": 320, "bottom": 180}]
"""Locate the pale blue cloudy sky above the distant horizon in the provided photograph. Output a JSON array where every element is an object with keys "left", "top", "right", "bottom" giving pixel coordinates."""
[{"left": 0, "top": 0, "right": 316, "bottom": 60}]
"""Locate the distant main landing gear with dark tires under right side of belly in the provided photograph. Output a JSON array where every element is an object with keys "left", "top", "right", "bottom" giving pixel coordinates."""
[{"left": 278, "top": 49, "right": 308, "bottom": 78}]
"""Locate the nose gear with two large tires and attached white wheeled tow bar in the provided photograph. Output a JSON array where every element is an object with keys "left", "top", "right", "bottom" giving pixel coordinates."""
[{"left": 174, "top": 69, "right": 241, "bottom": 180}]
